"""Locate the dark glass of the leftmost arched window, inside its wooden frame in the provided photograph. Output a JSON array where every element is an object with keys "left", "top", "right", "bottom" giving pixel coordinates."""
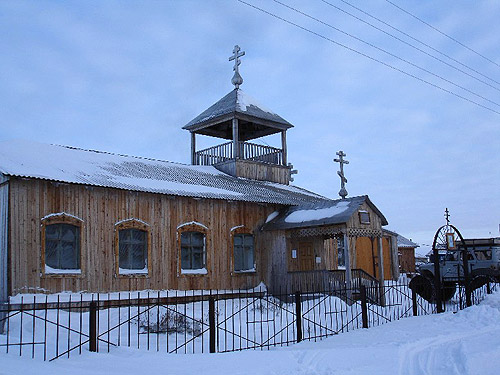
[{"left": 44, "top": 223, "right": 80, "bottom": 274}]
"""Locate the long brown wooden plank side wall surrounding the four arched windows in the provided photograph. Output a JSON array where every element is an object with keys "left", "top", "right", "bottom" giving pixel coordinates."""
[{"left": 10, "top": 178, "right": 277, "bottom": 294}]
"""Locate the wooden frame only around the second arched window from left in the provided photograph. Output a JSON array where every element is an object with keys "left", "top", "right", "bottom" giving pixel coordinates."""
[{"left": 114, "top": 218, "right": 152, "bottom": 278}]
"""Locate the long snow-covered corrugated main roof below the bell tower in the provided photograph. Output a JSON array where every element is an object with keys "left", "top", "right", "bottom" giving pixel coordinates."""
[{"left": 0, "top": 141, "right": 327, "bottom": 205}]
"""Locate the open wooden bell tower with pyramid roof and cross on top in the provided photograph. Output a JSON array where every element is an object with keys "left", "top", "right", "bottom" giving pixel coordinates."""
[{"left": 183, "top": 46, "right": 293, "bottom": 184}]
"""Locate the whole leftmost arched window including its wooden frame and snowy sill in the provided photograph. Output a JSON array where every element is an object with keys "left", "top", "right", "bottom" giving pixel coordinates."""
[{"left": 41, "top": 212, "right": 83, "bottom": 275}]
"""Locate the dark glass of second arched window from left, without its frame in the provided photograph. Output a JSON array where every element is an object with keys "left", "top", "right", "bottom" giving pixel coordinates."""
[{"left": 118, "top": 228, "right": 148, "bottom": 274}]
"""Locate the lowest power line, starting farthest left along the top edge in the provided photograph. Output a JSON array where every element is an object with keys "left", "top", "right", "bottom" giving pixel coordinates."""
[{"left": 237, "top": 0, "right": 500, "bottom": 115}]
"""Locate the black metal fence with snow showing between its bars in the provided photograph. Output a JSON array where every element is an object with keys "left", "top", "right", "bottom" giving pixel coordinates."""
[{"left": 0, "top": 280, "right": 496, "bottom": 360}]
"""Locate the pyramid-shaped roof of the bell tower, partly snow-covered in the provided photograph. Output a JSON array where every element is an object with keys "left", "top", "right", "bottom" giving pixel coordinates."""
[{"left": 183, "top": 89, "right": 293, "bottom": 130}]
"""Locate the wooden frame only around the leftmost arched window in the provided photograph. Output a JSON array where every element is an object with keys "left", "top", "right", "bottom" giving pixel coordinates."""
[{"left": 40, "top": 212, "right": 85, "bottom": 278}]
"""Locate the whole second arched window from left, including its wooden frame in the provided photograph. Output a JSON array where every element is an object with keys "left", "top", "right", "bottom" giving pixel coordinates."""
[{"left": 115, "top": 219, "right": 151, "bottom": 277}]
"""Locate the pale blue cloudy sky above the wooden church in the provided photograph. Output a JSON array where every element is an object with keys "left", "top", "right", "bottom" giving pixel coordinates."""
[{"left": 0, "top": 0, "right": 500, "bottom": 244}]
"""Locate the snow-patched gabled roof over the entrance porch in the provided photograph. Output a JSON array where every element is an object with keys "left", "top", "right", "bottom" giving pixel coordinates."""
[{"left": 263, "top": 195, "right": 387, "bottom": 230}]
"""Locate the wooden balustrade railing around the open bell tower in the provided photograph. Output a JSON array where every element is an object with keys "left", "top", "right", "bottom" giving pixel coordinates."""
[{"left": 194, "top": 142, "right": 283, "bottom": 165}]
